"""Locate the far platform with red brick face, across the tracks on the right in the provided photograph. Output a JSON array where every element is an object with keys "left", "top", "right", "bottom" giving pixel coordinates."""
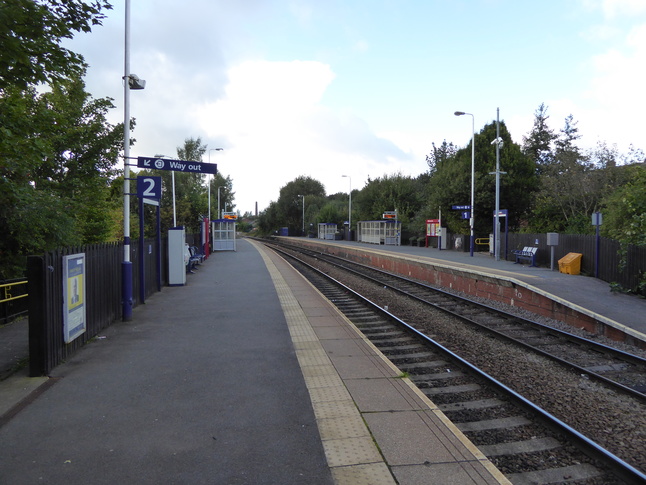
[{"left": 289, "top": 238, "right": 646, "bottom": 348}]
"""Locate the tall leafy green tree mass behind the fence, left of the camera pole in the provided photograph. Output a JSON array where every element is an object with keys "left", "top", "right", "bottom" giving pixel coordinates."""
[{"left": 0, "top": 0, "right": 116, "bottom": 278}]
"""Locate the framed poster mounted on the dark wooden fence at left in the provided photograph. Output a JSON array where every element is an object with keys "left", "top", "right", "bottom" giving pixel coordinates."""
[{"left": 63, "top": 253, "right": 86, "bottom": 344}]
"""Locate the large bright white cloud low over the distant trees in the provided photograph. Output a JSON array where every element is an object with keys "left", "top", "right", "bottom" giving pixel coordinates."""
[{"left": 195, "top": 61, "right": 412, "bottom": 212}]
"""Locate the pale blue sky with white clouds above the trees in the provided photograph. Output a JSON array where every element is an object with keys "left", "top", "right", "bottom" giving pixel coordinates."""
[{"left": 65, "top": 0, "right": 646, "bottom": 213}]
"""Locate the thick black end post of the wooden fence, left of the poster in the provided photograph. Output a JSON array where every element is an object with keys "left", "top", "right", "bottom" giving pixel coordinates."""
[{"left": 27, "top": 256, "right": 49, "bottom": 377}]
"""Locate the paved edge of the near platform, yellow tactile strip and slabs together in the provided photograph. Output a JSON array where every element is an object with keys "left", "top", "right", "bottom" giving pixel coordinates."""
[{"left": 252, "top": 239, "right": 509, "bottom": 485}]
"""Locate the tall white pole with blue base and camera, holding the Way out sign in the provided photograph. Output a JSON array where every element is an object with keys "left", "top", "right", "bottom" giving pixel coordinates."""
[{"left": 121, "top": 0, "right": 146, "bottom": 322}]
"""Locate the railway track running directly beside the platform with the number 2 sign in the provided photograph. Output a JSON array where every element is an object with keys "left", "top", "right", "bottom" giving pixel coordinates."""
[{"left": 264, "top": 239, "right": 646, "bottom": 484}]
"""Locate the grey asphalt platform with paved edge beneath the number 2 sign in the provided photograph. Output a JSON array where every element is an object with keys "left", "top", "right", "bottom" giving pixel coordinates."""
[{"left": 0, "top": 240, "right": 509, "bottom": 485}]
